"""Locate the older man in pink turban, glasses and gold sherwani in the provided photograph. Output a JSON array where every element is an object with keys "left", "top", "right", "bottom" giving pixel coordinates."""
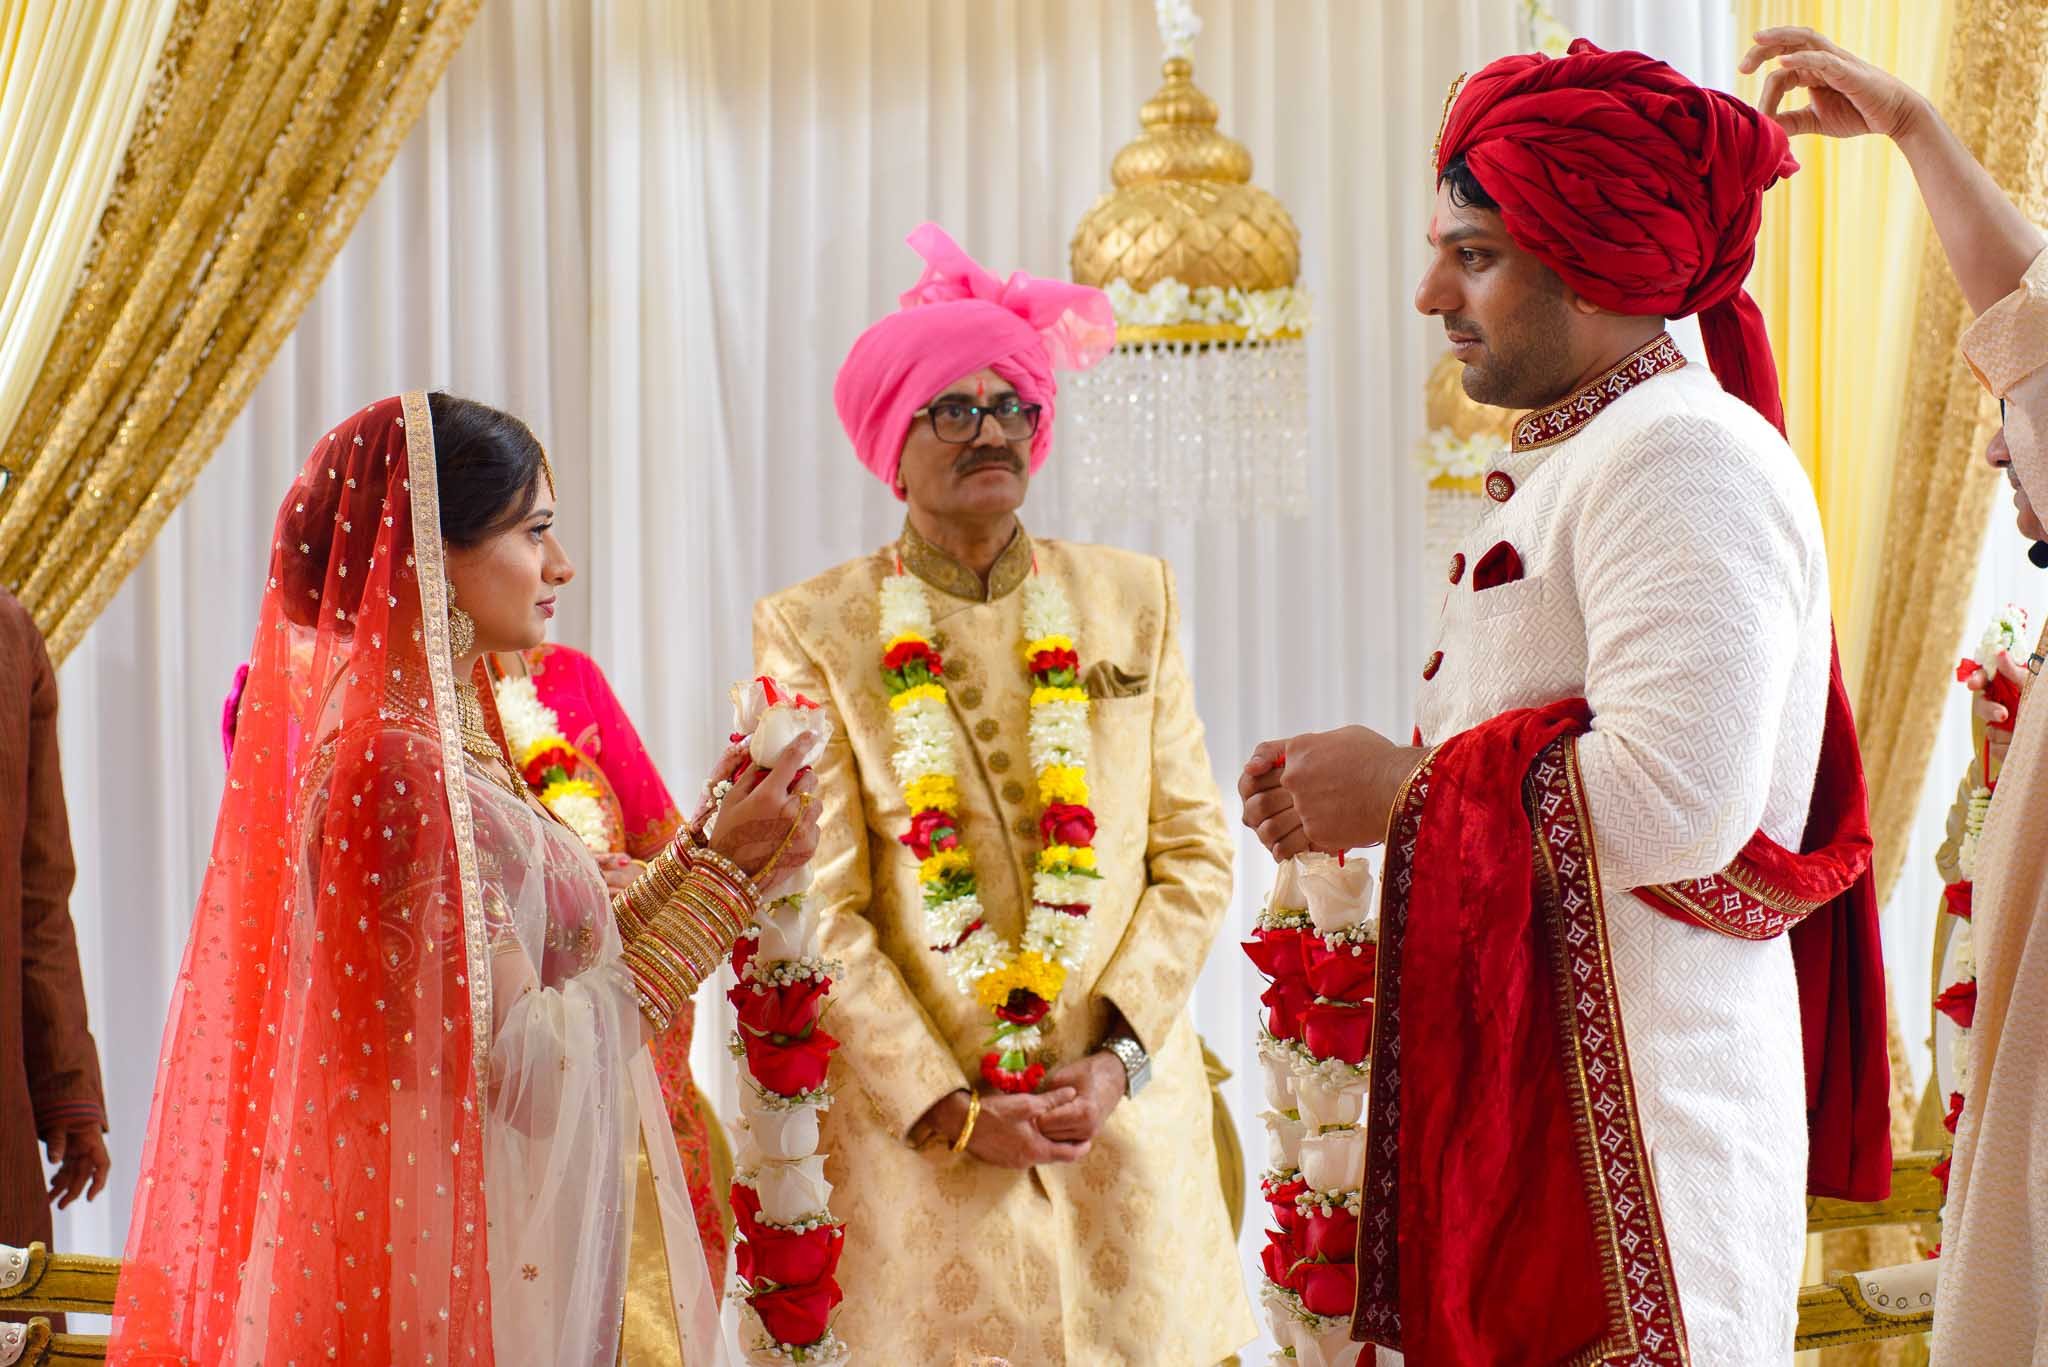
[{"left": 754, "top": 223, "right": 1253, "bottom": 1367}]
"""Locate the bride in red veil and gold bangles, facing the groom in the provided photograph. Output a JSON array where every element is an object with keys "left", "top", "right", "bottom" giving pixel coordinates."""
[{"left": 109, "top": 393, "right": 817, "bottom": 1367}]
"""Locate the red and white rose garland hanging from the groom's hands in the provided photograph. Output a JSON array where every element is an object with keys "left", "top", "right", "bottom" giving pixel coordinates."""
[{"left": 1245, "top": 855, "right": 1378, "bottom": 1367}]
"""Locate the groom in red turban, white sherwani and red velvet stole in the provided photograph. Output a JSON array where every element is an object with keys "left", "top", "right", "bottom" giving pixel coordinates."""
[{"left": 1241, "top": 41, "right": 1890, "bottom": 1367}]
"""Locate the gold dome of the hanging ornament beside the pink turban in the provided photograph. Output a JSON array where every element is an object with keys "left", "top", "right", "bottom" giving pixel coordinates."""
[{"left": 1071, "top": 55, "right": 1300, "bottom": 291}]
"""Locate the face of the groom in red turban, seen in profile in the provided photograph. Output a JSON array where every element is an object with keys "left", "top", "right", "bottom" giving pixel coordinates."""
[{"left": 1415, "top": 182, "right": 1577, "bottom": 408}]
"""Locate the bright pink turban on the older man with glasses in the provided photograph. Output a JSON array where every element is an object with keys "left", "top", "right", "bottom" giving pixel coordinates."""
[{"left": 831, "top": 223, "right": 1116, "bottom": 490}]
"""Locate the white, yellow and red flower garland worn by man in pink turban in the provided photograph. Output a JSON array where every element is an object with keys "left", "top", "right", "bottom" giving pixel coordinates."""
[{"left": 881, "top": 564, "right": 1102, "bottom": 1092}]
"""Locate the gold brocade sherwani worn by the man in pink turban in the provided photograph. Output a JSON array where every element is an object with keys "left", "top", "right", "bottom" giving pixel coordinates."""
[{"left": 754, "top": 527, "right": 1255, "bottom": 1367}]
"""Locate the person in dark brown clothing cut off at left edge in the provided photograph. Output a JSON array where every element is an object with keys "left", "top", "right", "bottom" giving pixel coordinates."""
[{"left": 0, "top": 588, "right": 109, "bottom": 1246}]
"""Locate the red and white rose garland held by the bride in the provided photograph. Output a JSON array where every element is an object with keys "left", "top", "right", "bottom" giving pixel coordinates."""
[{"left": 707, "top": 678, "right": 848, "bottom": 1367}]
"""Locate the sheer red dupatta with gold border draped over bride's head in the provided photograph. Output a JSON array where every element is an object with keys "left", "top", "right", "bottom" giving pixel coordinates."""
[{"left": 109, "top": 393, "right": 492, "bottom": 1363}]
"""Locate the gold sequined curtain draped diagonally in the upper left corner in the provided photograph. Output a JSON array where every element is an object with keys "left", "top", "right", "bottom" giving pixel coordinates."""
[{"left": 0, "top": 0, "right": 481, "bottom": 658}]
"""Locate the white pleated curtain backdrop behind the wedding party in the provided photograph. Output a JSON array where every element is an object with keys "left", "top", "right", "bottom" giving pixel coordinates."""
[{"left": 59, "top": 0, "right": 1933, "bottom": 1352}]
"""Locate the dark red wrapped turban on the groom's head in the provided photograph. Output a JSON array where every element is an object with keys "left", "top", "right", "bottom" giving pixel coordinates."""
[{"left": 1436, "top": 39, "right": 1798, "bottom": 432}]
